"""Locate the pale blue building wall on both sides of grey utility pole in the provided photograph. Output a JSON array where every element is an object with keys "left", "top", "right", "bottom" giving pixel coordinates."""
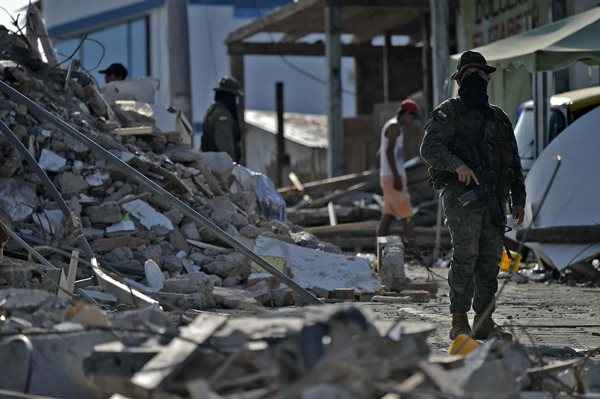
[{"left": 44, "top": 0, "right": 356, "bottom": 138}]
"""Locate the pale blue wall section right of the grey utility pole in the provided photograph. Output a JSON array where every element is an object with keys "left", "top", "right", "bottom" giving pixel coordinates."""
[{"left": 188, "top": 0, "right": 356, "bottom": 133}]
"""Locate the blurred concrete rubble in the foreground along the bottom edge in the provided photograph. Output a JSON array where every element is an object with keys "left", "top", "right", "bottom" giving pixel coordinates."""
[{"left": 0, "top": 294, "right": 600, "bottom": 399}]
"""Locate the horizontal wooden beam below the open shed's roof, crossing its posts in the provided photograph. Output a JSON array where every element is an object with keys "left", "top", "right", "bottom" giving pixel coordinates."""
[{"left": 228, "top": 42, "right": 420, "bottom": 57}]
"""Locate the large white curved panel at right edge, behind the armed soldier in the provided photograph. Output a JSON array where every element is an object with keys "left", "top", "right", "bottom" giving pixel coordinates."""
[{"left": 511, "top": 107, "right": 600, "bottom": 270}]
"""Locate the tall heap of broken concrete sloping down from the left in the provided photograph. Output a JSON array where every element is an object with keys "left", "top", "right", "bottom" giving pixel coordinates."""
[{"left": 0, "top": 27, "right": 346, "bottom": 309}]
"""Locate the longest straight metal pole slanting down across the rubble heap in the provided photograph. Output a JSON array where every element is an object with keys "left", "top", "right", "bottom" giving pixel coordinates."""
[{"left": 0, "top": 80, "right": 322, "bottom": 304}]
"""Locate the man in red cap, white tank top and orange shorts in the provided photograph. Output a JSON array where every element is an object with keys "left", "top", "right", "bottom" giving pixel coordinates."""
[{"left": 377, "top": 100, "right": 419, "bottom": 242}]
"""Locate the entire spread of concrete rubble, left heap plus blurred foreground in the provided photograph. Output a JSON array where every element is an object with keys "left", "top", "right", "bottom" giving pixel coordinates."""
[{"left": 0, "top": 14, "right": 598, "bottom": 399}]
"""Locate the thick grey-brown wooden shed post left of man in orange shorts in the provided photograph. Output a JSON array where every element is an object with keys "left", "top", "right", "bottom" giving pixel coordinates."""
[{"left": 325, "top": 4, "right": 344, "bottom": 177}]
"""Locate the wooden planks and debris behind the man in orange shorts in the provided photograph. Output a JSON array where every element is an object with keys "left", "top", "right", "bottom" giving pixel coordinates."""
[{"left": 279, "top": 162, "right": 450, "bottom": 252}]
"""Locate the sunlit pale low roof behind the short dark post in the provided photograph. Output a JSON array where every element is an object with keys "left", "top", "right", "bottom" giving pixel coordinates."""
[{"left": 245, "top": 110, "right": 329, "bottom": 148}]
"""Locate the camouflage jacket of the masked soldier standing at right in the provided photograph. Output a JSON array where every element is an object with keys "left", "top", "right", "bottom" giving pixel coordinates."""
[{"left": 421, "top": 98, "right": 525, "bottom": 212}]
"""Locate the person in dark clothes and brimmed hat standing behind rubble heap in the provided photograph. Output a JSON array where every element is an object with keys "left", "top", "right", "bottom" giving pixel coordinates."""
[{"left": 202, "top": 77, "right": 243, "bottom": 162}]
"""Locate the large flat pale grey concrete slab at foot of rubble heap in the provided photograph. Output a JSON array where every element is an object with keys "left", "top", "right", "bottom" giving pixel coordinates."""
[{"left": 255, "top": 236, "right": 381, "bottom": 292}]
